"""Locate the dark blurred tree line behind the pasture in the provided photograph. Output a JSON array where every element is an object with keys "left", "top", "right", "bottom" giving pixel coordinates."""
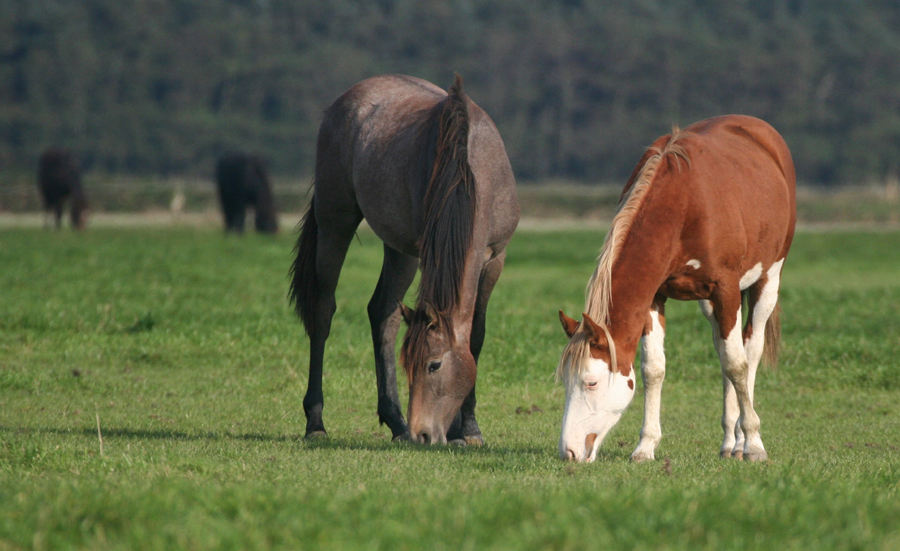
[{"left": 0, "top": 0, "right": 900, "bottom": 185}]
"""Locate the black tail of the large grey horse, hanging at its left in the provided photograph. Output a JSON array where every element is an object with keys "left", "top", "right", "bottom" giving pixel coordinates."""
[{"left": 289, "top": 197, "right": 319, "bottom": 336}]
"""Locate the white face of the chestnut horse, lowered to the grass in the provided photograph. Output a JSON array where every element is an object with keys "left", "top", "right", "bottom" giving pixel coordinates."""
[{"left": 559, "top": 359, "right": 635, "bottom": 462}]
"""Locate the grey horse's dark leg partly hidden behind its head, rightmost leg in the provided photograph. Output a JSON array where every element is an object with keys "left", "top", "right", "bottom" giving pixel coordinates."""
[{"left": 447, "top": 251, "right": 506, "bottom": 445}]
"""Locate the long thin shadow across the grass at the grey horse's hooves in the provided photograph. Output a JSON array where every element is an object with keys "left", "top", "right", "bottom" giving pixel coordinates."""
[{"left": 0, "top": 425, "right": 556, "bottom": 460}]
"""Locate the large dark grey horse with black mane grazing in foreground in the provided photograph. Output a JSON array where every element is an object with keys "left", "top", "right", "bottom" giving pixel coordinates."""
[{"left": 290, "top": 75, "right": 519, "bottom": 444}]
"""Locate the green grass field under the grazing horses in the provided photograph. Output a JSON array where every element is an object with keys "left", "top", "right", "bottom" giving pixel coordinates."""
[{"left": 0, "top": 228, "right": 900, "bottom": 551}]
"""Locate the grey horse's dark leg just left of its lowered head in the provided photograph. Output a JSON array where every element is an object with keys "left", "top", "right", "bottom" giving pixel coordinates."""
[{"left": 368, "top": 245, "right": 419, "bottom": 440}]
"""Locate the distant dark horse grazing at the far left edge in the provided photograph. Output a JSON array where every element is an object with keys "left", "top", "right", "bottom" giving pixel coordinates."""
[{"left": 38, "top": 147, "right": 87, "bottom": 230}]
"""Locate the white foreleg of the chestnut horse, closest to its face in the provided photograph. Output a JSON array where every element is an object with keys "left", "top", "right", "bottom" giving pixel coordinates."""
[{"left": 631, "top": 310, "right": 666, "bottom": 461}]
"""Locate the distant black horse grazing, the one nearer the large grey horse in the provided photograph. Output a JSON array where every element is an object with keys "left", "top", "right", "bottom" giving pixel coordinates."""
[{"left": 216, "top": 153, "right": 278, "bottom": 233}]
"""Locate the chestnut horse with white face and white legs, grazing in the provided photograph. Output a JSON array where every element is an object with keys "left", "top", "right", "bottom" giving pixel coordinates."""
[{"left": 557, "top": 115, "right": 796, "bottom": 461}]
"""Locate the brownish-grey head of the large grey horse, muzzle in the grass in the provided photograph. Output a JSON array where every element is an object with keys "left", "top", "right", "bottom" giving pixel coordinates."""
[{"left": 400, "top": 303, "right": 476, "bottom": 444}]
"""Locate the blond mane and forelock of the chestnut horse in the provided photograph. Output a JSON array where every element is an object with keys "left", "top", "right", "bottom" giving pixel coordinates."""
[{"left": 556, "top": 126, "right": 691, "bottom": 381}]
